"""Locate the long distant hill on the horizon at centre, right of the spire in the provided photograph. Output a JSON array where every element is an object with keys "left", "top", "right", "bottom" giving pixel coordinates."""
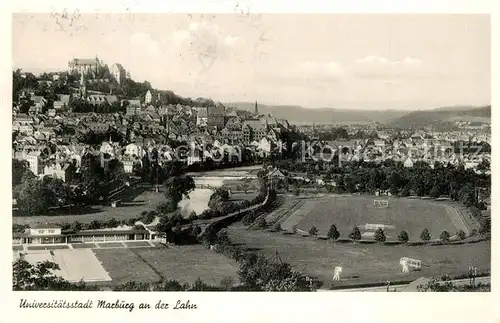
[{"left": 224, "top": 102, "right": 408, "bottom": 124}]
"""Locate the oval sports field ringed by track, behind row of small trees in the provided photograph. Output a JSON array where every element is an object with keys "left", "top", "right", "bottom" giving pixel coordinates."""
[{"left": 282, "top": 195, "right": 469, "bottom": 240}]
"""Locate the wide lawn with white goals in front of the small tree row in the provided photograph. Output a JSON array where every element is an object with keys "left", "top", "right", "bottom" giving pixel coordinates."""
[{"left": 228, "top": 226, "right": 491, "bottom": 288}]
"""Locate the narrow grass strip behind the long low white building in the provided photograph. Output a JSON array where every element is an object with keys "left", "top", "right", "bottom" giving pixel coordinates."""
[{"left": 12, "top": 188, "right": 165, "bottom": 225}]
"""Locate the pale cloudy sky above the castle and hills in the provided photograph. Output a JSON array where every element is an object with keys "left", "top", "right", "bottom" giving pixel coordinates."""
[{"left": 12, "top": 12, "right": 490, "bottom": 109}]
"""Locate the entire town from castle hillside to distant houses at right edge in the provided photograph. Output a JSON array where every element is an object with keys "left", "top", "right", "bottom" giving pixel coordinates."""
[{"left": 12, "top": 58, "right": 491, "bottom": 186}]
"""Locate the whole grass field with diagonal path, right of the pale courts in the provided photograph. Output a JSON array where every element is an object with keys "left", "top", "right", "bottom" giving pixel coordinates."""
[{"left": 94, "top": 245, "right": 242, "bottom": 285}]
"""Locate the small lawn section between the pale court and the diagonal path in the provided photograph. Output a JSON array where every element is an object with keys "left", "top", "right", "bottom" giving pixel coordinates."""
[{"left": 92, "top": 248, "right": 160, "bottom": 284}]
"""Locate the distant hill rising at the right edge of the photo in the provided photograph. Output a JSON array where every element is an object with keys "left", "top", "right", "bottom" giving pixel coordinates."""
[{"left": 389, "top": 106, "right": 491, "bottom": 128}]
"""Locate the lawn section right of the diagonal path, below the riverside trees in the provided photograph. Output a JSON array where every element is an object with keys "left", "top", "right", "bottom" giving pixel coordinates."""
[{"left": 133, "top": 245, "right": 239, "bottom": 285}]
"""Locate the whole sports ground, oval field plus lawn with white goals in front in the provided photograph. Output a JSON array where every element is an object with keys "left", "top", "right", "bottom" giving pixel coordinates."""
[{"left": 229, "top": 195, "right": 491, "bottom": 288}]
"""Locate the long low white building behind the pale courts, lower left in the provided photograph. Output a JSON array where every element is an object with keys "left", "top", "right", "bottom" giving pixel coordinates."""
[{"left": 12, "top": 223, "right": 159, "bottom": 245}]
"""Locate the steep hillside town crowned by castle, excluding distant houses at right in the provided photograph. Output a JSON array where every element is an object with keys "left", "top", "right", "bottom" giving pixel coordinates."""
[{"left": 12, "top": 58, "right": 292, "bottom": 185}]
